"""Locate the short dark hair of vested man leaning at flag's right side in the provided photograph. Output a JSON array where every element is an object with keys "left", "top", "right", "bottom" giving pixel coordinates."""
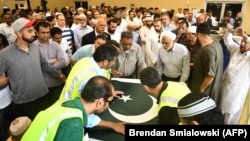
[{"left": 139, "top": 67, "right": 162, "bottom": 88}]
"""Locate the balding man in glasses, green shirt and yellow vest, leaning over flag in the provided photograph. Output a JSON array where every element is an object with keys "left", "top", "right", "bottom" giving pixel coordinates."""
[{"left": 22, "top": 76, "right": 116, "bottom": 141}]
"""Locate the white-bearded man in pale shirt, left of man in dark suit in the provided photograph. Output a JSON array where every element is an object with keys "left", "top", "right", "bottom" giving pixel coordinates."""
[{"left": 73, "top": 14, "right": 93, "bottom": 49}]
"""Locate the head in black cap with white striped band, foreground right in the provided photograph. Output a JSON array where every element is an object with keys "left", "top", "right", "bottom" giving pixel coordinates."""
[{"left": 177, "top": 93, "right": 223, "bottom": 125}]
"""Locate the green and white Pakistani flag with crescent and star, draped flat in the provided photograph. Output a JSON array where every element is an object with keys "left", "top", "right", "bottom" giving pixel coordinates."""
[{"left": 89, "top": 78, "right": 158, "bottom": 141}]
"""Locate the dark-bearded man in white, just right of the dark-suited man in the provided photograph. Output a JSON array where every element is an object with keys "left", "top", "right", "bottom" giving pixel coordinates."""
[{"left": 106, "top": 19, "right": 121, "bottom": 42}]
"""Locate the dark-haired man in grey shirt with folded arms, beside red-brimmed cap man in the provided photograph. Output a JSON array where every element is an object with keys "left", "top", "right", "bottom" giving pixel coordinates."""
[{"left": 33, "top": 21, "right": 66, "bottom": 103}]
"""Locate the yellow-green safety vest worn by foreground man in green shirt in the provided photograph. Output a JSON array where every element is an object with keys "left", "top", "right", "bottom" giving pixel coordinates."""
[{"left": 21, "top": 100, "right": 84, "bottom": 141}]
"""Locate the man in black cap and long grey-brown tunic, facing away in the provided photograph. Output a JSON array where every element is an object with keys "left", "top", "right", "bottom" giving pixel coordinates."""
[{"left": 188, "top": 23, "right": 223, "bottom": 105}]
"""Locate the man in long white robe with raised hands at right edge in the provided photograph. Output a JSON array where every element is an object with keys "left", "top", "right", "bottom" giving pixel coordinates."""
[{"left": 221, "top": 24, "right": 250, "bottom": 124}]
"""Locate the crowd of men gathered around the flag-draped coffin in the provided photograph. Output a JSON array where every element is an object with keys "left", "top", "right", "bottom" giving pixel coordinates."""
[{"left": 0, "top": 3, "right": 250, "bottom": 141}]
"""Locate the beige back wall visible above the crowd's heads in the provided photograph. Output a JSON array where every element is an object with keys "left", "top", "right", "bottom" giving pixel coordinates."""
[{"left": 0, "top": 0, "right": 250, "bottom": 34}]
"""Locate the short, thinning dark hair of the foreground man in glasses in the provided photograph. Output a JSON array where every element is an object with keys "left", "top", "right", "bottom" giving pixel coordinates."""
[{"left": 81, "top": 75, "right": 113, "bottom": 102}]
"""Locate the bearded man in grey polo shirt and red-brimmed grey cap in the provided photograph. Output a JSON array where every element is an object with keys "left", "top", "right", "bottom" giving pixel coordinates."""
[{"left": 0, "top": 18, "right": 66, "bottom": 119}]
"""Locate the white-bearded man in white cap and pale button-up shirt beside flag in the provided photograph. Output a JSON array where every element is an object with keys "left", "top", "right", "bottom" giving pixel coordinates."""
[{"left": 156, "top": 31, "right": 190, "bottom": 82}]
